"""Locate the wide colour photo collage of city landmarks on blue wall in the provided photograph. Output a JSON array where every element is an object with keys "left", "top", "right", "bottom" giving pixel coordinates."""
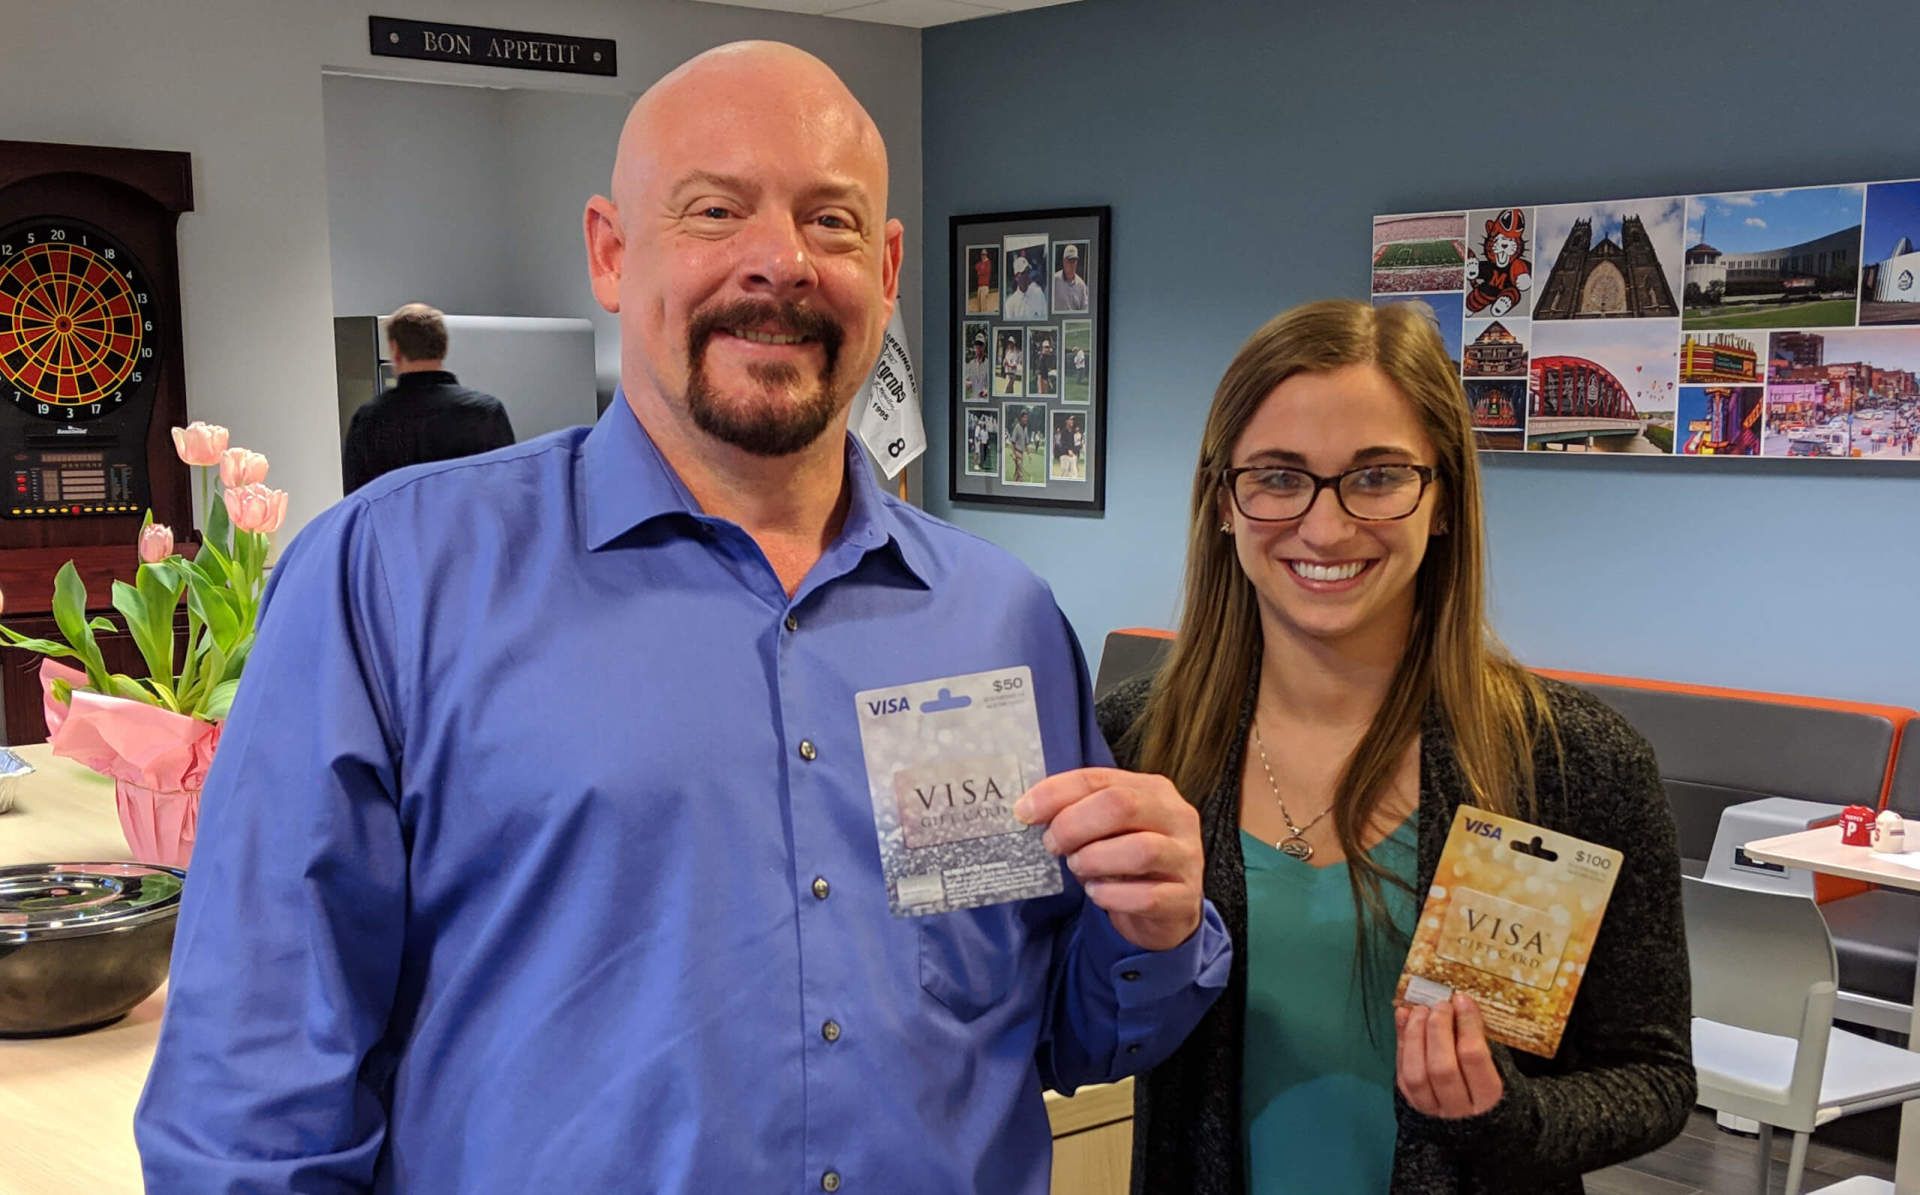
[{"left": 1371, "top": 181, "right": 1920, "bottom": 465}]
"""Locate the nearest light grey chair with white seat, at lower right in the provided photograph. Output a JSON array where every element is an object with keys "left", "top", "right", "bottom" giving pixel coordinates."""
[{"left": 1682, "top": 876, "right": 1920, "bottom": 1195}]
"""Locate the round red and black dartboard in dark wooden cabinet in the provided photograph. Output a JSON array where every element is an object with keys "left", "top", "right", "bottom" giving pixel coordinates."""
[{"left": 0, "top": 217, "right": 156, "bottom": 423}]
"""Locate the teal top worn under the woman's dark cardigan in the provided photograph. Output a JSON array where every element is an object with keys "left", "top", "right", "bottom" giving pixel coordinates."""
[{"left": 1240, "top": 817, "right": 1419, "bottom": 1195}]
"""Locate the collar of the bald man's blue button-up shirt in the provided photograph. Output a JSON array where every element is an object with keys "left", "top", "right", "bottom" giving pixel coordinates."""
[{"left": 578, "top": 390, "right": 933, "bottom": 586}]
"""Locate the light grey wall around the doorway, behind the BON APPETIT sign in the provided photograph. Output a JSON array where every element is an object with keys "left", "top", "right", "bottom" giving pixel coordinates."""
[{"left": 0, "top": 0, "right": 922, "bottom": 542}]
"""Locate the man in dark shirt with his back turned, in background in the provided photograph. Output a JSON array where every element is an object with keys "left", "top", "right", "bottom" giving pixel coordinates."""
[{"left": 340, "top": 304, "right": 513, "bottom": 494}]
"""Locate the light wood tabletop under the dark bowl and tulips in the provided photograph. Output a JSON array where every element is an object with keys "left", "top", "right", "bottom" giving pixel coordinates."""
[{"left": 0, "top": 744, "right": 155, "bottom": 1195}]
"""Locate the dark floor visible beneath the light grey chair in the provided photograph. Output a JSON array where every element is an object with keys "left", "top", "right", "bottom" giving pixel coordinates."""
[{"left": 1586, "top": 1109, "right": 1893, "bottom": 1195}]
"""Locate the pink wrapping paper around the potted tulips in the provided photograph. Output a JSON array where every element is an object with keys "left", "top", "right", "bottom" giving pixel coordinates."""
[{"left": 40, "top": 659, "right": 221, "bottom": 866}]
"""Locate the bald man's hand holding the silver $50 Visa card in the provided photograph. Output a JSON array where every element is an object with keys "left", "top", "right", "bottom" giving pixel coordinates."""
[{"left": 1014, "top": 768, "right": 1202, "bottom": 951}]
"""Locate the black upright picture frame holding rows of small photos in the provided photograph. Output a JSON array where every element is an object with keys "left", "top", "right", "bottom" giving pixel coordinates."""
[{"left": 947, "top": 206, "right": 1114, "bottom": 513}]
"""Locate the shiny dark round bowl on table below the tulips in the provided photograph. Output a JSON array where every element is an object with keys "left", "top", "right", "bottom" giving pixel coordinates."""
[{"left": 0, "top": 863, "right": 186, "bottom": 1037}]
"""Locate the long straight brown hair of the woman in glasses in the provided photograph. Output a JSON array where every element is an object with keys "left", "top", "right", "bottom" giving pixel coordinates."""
[{"left": 1129, "top": 300, "right": 1553, "bottom": 959}]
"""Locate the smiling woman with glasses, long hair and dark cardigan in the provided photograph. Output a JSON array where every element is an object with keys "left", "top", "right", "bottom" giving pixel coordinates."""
[{"left": 1100, "top": 302, "right": 1693, "bottom": 1195}]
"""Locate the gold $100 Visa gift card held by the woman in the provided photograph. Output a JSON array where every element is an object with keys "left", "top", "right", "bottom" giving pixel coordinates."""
[{"left": 1396, "top": 805, "right": 1622, "bottom": 1059}]
